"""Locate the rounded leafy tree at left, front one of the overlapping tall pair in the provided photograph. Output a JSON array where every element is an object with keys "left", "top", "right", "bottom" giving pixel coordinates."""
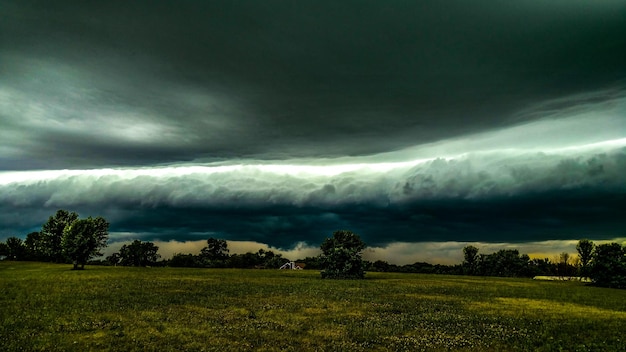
[{"left": 61, "top": 216, "right": 109, "bottom": 270}]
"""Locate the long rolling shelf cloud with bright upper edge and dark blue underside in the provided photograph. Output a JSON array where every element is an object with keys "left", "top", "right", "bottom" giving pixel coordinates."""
[{"left": 0, "top": 136, "right": 626, "bottom": 248}]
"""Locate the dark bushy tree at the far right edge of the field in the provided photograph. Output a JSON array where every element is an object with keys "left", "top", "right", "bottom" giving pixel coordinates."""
[{"left": 589, "top": 243, "right": 626, "bottom": 288}]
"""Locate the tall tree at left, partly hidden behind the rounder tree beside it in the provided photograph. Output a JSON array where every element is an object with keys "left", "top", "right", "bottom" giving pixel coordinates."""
[{"left": 40, "top": 209, "right": 78, "bottom": 263}]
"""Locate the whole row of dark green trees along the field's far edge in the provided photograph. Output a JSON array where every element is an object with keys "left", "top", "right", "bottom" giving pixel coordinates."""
[{"left": 0, "top": 210, "right": 626, "bottom": 288}]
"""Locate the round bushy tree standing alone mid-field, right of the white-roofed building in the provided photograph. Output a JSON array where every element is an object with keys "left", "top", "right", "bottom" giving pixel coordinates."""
[{"left": 321, "top": 230, "right": 366, "bottom": 279}]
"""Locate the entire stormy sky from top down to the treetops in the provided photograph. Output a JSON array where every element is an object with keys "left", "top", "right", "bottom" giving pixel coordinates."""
[{"left": 0, "top": 0, "right": 626, "bottom": 264}]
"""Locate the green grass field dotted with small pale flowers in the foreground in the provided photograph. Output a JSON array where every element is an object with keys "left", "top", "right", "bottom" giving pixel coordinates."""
[{"left": 0, "top": 262, "right": 626, "bottom": 351}]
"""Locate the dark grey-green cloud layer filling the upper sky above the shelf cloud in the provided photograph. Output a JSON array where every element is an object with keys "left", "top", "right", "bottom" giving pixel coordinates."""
[{"left": 0, "top": 1, "right": 626, "bottom": 170}]
